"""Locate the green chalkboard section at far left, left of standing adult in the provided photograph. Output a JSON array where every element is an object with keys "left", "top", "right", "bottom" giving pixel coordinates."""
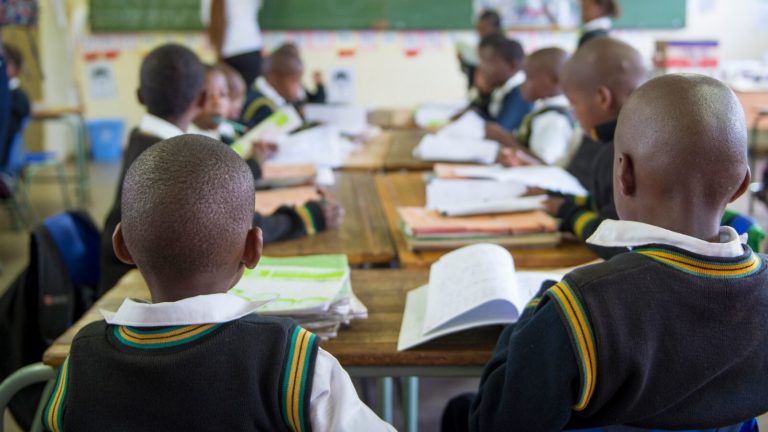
[{"left": 89, "top": 0, "right": 203, "bottom": 32}]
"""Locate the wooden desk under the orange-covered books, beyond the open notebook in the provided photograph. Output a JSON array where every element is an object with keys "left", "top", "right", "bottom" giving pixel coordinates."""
[{"left": 376, "top": 173, "right": 595, "bottom": 269}]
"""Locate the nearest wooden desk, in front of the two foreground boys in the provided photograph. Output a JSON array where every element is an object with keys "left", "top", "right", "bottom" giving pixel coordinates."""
[{"left": 43, "top": 269, "right": 501, "bottom": 376}]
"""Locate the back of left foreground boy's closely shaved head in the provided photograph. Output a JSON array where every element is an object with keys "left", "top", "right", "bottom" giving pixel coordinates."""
[{"left": 121, "top": 134, "right": 254, "bottom": 281}]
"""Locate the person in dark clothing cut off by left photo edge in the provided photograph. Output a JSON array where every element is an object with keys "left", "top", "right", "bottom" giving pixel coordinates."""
[{"left": 0, "top": 43, "right": 31, "bottom": 170}]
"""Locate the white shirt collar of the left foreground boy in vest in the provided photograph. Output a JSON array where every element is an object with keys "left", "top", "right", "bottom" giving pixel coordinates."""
[{"left": 99, "top": 293, "right": 270, "bottom": 327}]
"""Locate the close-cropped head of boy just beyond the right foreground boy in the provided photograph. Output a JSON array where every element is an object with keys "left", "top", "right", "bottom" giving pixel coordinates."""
[{"left": 563, "top": 37, "right": 646, "bottom": 101}]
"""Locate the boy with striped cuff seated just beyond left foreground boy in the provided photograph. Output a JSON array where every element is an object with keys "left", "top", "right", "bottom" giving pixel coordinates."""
[{"left": 98, "top": 44, "right": 343, "bottom": 295}]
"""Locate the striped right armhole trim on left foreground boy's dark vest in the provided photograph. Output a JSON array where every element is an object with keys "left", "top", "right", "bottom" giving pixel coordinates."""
[{"left": 281, "top": 326, "right": 316, "bottom": 432}]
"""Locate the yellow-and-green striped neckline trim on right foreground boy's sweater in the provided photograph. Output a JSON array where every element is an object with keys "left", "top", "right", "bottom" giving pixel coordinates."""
[{"left": 633, "top": 248, "right": 763, "bottom": 279}]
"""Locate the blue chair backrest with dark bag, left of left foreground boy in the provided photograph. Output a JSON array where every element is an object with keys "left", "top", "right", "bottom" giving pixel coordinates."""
[{"left": 43, "top": 212, "right": 100, "bottom": 287}]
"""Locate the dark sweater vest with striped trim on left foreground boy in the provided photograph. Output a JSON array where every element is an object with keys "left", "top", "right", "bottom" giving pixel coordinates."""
[{"left": 43, "top": 315, "right": 318, "bottom": 431}]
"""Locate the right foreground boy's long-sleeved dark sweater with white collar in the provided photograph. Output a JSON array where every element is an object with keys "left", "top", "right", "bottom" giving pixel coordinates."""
[{"left": 469, "top": 221, "right": 768, "bottom": 432}]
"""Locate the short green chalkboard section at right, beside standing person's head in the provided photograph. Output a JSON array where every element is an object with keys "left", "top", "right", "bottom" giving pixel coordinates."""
[{"left": 614, "top": 0, "right": 686, "bottom": 29}]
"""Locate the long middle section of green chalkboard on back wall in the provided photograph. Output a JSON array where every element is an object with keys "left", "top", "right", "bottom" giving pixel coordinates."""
[{"left": 259, "top": 0, "right": 472, "bottom": 30}]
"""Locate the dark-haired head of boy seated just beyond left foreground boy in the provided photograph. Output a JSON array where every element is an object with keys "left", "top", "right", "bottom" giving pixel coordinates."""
[{"left": 139, "top": 44, "right": 205, "bottom": 119}]
